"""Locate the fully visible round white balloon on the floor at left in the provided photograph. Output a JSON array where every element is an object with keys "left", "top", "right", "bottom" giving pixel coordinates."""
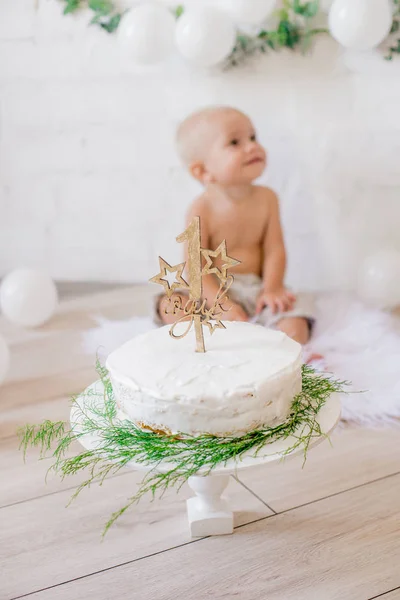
[{"left": 0, "top": 269, "right": 58, "bottom": 327}]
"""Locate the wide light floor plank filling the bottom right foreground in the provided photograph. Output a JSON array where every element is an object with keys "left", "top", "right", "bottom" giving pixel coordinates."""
[{"left": 24, "top": 476, "right": 400, "bottom": 600}]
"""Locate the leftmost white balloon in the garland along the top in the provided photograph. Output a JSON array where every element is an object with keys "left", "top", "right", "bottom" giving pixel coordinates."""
[{"left": 117, "top": 2, "right": 175, "bottom": 64}]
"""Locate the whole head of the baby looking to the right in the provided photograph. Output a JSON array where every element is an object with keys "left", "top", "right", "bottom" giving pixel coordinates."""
[{"left": 176, "top": 106, "right": 266, "bottom": 185}]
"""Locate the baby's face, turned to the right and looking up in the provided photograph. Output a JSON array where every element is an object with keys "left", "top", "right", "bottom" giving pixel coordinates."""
[{"left": 204, "top": 110, "right": 266, "bottom": 185}]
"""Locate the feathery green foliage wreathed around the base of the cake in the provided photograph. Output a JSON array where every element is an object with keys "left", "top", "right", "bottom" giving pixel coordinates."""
[{"left": 19, "top": 364, "right": 346, "bottom": 535}]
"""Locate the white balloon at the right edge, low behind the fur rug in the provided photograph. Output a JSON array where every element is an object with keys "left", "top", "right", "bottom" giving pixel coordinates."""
[{"left": 358, "top": 249, "right": 400, "bottom": 308}]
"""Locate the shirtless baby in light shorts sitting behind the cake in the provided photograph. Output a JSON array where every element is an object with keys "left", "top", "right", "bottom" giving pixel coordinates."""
[{"left": 157, "top": 107, "right": 314, "bottom": 344}]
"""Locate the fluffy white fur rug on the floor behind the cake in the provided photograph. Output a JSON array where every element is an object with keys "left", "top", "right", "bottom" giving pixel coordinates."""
[{"left": 83, "top": 295, "right": 400, "bottom": 426}]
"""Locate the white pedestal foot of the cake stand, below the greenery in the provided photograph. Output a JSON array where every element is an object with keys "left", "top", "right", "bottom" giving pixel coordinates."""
[{"left": 186, "top": 475, "right": 233, "bottom": 537}]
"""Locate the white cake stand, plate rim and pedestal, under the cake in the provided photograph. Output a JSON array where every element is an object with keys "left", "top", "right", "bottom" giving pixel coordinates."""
[{"left": 71, "top": 381, "right": 340, "bottom": 537}]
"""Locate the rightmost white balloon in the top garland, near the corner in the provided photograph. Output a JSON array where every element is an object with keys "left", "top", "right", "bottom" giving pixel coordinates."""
[{"left": 329, "top": 0, "right": 393, "bottom": 50}]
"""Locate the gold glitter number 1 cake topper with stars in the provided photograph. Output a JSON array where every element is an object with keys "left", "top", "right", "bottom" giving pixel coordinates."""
[{"left": 150, "top": 217, "right": 240, "bottom": 352}]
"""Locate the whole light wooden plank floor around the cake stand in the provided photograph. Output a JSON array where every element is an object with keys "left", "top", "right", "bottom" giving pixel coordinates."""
[{"left": 0, "top": 288, "right": 400, "bottom": 600}]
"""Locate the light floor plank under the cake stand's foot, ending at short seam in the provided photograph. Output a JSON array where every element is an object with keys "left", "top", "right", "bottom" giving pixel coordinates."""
[{"left": 0, "top": 471, "right": 271, "bottom": 600}]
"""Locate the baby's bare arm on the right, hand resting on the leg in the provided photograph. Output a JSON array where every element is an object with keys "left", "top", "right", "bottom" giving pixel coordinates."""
[{"left": 256, "top": 190, "right": 295, "bottom": 313}]
